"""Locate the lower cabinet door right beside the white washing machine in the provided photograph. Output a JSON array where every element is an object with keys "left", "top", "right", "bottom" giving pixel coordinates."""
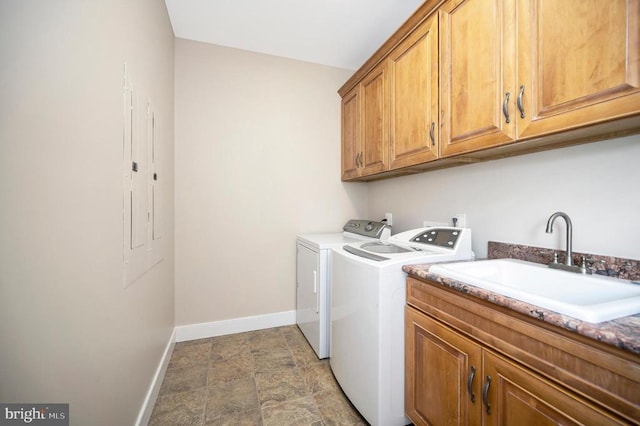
[{"left": 405, "top": 307, "right": 480, "bottom": 426}]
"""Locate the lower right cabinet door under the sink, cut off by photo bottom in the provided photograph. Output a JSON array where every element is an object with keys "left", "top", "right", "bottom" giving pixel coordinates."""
[{"left": 478, "top": 350, "right": 623, "bottom": 426}]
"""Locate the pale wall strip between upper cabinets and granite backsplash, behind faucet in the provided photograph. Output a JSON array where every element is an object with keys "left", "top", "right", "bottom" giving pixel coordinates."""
[{"left": 369, "top": 135, "right": 640, "bottom": 259}]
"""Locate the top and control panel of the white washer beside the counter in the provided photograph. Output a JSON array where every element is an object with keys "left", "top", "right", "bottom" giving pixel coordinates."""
[{"left": 342, "top": 226, "right": 475, "bottom": 264}]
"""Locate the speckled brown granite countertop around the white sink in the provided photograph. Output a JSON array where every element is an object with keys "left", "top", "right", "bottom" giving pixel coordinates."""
[{"left": 402, "top": 242, "right": 640, "bottom": 355}]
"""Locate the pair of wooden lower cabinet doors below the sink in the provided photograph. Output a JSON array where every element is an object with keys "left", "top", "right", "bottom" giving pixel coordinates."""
[{"left": 405, "top": 298, "right": 628, "bottom": 426}]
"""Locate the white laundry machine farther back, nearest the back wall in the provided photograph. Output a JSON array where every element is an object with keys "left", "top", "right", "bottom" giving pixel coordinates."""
[{"left": 296, "top": 219, "right": 391, "bottom": 359}]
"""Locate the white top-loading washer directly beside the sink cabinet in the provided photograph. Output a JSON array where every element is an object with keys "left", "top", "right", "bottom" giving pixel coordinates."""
[{"left": 329, "top": 227, "right": 474, "bottom": 426}]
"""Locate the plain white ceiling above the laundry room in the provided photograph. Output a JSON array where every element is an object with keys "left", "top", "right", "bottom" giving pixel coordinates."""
[{"left": 165, "top": 0, "right": 424, "bottom": 70}]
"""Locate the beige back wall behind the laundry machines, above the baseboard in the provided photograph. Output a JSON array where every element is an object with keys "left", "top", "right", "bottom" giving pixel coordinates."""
[{"left": 176, "top": 39, "right": 367, "bottom": 325}]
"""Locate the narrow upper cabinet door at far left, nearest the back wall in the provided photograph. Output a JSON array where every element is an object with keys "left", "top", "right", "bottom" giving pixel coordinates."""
[{"left": 342, "top": 86, "right": 362, "bottom": 180}]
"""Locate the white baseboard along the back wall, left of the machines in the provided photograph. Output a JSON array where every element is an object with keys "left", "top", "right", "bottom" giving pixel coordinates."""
[{"left": 176, "top": 311, "right": 296, "bottom": 342}]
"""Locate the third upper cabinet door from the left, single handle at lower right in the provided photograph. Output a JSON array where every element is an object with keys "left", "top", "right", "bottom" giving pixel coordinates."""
[{"left": 388, "top": 14, "right": 439, "bottom": 169}]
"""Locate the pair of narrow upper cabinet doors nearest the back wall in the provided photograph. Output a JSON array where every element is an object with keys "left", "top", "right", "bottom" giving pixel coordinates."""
[{"left": 342, "top": 64, "right": 389, "bottom": 180}]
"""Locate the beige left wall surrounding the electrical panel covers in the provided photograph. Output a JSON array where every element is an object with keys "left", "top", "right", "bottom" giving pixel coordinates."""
[{"left": 0, "top": 0, "right": 174, "bottom": 425}]
